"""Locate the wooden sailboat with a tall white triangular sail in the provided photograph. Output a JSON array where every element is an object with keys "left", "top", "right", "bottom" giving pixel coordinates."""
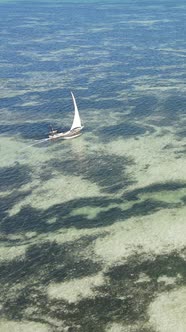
[{"left": 49, "top": 92, "right": 83, "bottom": 139}]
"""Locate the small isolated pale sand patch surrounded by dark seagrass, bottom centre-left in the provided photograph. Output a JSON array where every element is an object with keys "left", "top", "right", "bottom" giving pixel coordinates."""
[{"left": 48, "top": 273, "right": 105, "bottom": 303}]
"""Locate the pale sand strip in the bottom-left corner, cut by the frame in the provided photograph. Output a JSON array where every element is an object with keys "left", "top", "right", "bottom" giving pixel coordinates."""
[{"left": 0, "top": 319, "right": 49, "bottom": 332}]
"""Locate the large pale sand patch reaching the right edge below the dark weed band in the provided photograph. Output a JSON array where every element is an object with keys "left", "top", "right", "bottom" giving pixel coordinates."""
[{"left": 94, "top": 207, "right": 186, "bottom": 264}]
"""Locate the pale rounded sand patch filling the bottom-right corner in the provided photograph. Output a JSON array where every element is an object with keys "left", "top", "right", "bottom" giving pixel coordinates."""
[{"left": 148, "top": 287, "right": 186, "bottom": 332}]
